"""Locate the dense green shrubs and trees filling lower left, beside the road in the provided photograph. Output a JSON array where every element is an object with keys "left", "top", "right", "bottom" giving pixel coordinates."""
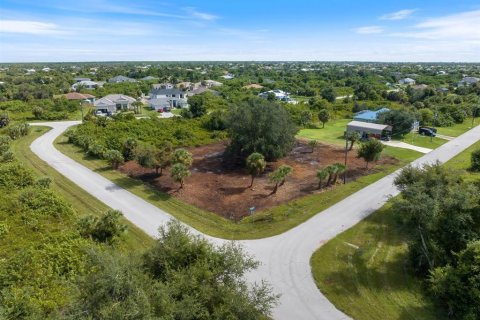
[{"left": 0, "top": 128, "right": 277, "bottom": 319}]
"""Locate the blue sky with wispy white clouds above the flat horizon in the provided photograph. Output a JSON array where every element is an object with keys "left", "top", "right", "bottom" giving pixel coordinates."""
[{"left": 0, "top": 0, "right": 480, "bottom": 62}]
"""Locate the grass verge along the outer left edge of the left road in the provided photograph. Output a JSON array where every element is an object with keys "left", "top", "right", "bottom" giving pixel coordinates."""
[{"left": 11, "top": 126, "right": 153, "bottom": 250}]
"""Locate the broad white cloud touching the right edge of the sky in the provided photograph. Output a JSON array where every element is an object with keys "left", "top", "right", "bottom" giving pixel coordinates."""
[{"left": 393, "top": 10, "right": 480, "bottom": 42}]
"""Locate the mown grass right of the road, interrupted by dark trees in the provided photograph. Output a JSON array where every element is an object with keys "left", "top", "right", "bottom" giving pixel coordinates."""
[{"left": 311, "top": 137, "right": 480, "bottom": 320}]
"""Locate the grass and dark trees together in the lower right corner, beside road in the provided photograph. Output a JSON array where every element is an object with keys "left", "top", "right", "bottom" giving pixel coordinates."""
[{"left": 311, "top": 142, "right": 480, "bottom": 319}]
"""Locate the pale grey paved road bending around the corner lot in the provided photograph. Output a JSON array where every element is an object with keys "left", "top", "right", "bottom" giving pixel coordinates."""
[{"left": 31, "top": 121, "right": 480, "bottom": 320}]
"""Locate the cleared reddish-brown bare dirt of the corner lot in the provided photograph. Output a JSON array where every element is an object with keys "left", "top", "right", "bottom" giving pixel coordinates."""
[{"left": 120, "top": 141, "right": 397, "bottom": 218}]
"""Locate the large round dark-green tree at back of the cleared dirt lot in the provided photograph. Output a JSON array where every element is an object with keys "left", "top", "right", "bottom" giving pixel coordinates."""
[{"left": 226, "top": 98, "right": 297, "bottom": 160}]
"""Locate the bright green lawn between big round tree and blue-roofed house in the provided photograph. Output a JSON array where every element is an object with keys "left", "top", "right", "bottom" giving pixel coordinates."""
[{"left": 297, "top": 119, "right": 352, "bottom": 146}]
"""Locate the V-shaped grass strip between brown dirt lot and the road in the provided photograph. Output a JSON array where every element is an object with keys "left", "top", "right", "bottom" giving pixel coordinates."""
[{"left": 56, "top": 132, "right": 421, "bottom": 239}]
